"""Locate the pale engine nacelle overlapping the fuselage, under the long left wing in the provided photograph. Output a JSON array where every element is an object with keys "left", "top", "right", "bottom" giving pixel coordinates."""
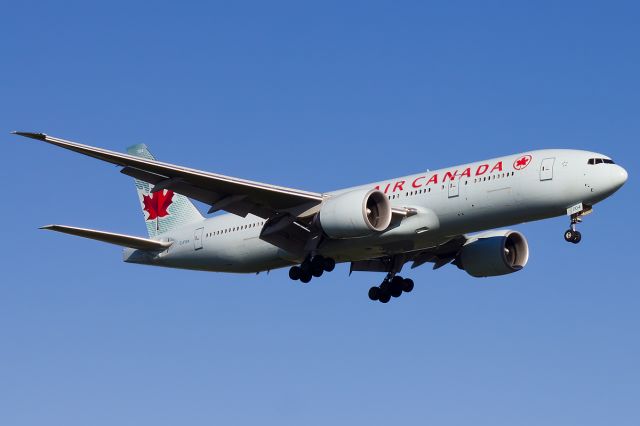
[{"left": 318, "top": 189, "right": 391, "bottom": 238}]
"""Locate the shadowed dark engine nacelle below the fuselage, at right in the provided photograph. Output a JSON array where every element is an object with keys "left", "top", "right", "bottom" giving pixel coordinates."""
[{"left": 455, "top": 231, "right": 529, "bottom": 277}]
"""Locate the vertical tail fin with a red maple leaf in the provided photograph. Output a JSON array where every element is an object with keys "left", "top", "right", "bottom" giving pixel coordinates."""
[{"left": 127, "top": 144, "right": 204, "bottom": 237}]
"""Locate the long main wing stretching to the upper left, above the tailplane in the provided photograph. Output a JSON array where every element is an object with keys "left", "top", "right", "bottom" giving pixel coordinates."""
[{"left": 13, "top": 132, "right": 322, "bottom": 219}]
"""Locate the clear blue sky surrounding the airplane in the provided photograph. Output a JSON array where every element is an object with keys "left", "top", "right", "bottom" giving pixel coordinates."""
[{"left": 0, "top": 1, "right": 640, "bottom": 426}]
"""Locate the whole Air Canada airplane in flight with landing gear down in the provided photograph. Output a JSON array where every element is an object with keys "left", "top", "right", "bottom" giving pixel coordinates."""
[{"left": 12, "top": 132, "right": 628, "bottom": 303}]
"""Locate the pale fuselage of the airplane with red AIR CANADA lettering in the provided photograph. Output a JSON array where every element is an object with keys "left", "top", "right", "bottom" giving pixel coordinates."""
[{"left": 124, "top": 149, "right": 627, "bottom": 273}]
